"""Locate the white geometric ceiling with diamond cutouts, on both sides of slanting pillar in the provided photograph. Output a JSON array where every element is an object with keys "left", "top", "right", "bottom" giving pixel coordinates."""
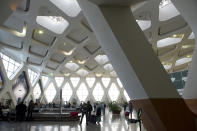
[{"left": 0, "top": 0, "right": 195, "bottom": 77}]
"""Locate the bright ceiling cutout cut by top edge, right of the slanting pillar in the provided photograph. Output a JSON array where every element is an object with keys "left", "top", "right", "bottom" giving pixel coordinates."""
[{"left": 159, "top": 0, "right": 180, "bottom": 21}]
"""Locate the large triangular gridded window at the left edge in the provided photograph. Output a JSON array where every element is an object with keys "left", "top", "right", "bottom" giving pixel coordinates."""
[{"left": 0, "top": 53, "right": 20, "bottom": 79}]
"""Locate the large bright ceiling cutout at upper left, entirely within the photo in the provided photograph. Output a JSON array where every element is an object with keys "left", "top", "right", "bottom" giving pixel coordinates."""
[{"left": 36, "top": 16, "right": 69, "bottom": 34}]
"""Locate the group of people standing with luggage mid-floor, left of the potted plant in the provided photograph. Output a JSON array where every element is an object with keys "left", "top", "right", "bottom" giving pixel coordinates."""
[{"left": 79, "top": 101, "right": 106, "bottom": 125}]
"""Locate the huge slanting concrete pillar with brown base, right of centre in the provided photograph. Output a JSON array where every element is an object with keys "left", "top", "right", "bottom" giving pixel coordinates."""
[{"left": 78, "top": 0, "right": 195, "bottom": 131}]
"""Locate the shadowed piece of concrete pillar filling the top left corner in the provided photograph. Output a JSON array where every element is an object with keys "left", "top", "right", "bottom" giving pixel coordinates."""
[{"left": 0, "top": 0, "right": 23, "bottom": 26}]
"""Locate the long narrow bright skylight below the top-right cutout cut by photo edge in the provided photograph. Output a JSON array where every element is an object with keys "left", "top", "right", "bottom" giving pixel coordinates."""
[{"left": 157, "top": 37, "right": 182, "bottom": 48}]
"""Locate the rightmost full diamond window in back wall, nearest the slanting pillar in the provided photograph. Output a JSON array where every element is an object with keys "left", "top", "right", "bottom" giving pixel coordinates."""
[{"left": 108, "top": 83, "right": 120, "bottom": 101}]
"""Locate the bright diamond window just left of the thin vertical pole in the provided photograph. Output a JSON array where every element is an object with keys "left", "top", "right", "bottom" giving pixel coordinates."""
[{"left": 45, "top": 83, "right": 57, "bottom": 103}]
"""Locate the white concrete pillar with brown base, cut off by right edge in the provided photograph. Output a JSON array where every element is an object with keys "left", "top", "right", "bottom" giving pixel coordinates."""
[{"left": 172, "top": 0, "right": 197, "bottom": 114}]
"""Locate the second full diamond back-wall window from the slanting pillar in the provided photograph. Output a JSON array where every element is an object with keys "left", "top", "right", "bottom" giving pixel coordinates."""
[{"left": 93, "top": 83, "right": 104, "bottom": 101}]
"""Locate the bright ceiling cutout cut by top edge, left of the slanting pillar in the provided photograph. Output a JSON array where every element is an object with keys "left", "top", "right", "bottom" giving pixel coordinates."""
[{"left": 50, "top": 0, "right": 81, "bottom": 17}]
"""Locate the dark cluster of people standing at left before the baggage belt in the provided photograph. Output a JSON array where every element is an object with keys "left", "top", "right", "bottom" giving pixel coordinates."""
[{"left": 15, "top": 100, "right": 35, "bottom": 121}]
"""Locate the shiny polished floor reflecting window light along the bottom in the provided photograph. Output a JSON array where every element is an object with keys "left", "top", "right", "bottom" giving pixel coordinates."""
[{"left": 0, "top": 111, "right": 145, "bottom": 131}]
